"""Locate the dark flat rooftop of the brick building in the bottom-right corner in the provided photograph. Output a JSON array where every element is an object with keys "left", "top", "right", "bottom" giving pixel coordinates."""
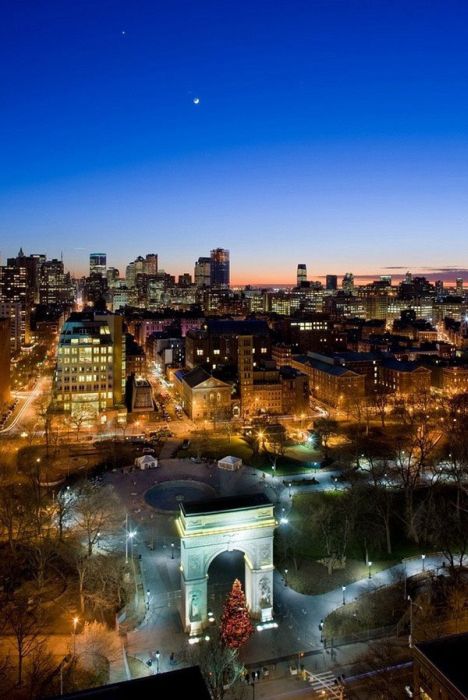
[{"left": 415, "top": 633, "right": 468, "bottom": 696}]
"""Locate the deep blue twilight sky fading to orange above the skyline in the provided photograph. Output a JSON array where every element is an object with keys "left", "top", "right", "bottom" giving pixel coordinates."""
[{"left": 0, "top": 0, "right": 468, "bottom": 282}]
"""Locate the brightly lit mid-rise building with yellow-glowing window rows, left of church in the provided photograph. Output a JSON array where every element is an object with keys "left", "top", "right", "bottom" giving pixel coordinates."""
[{"left": 54, "top": 311, "right": 126, "bottom": 414}]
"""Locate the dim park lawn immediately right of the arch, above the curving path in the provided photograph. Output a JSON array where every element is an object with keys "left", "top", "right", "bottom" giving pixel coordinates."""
[{"left": 283, "top": 557, "right": 396, "bottom": 595}]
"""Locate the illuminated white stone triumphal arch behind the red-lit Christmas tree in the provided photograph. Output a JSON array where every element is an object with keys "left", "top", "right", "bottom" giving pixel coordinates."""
[{"left": 177, "top": 493, "right": 276, "bottom": 636}]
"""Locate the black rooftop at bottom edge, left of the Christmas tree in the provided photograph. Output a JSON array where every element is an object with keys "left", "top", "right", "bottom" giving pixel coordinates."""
[{"left": 50, "top": 666, "right": 211, "bottom": 700}]
